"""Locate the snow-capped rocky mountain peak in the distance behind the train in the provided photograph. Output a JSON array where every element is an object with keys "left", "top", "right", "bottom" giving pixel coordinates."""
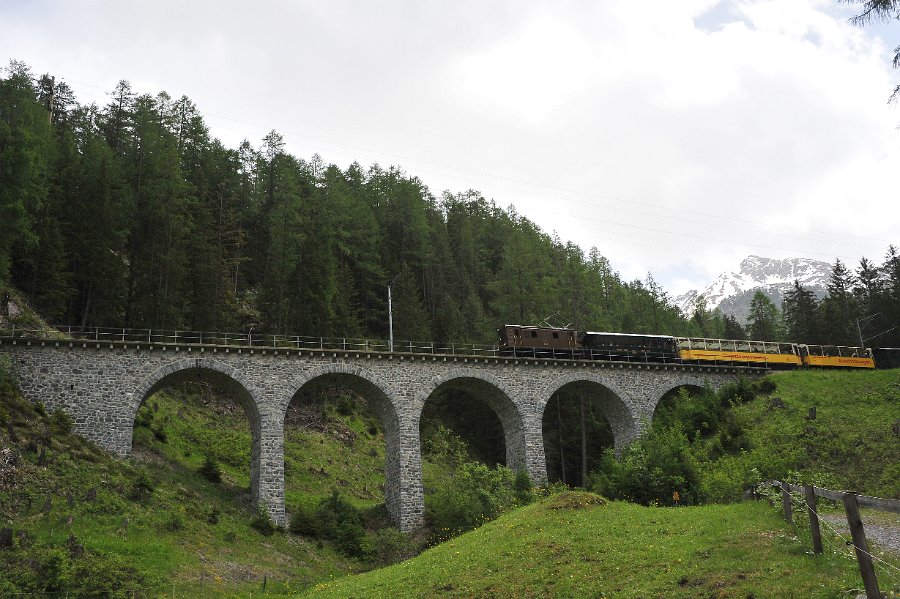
[{"left": 675, "top": 256, "right": 831, "bottom": 322}]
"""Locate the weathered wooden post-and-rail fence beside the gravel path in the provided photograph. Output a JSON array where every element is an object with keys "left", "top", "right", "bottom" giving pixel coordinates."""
[{"left": 769, "top": 480, "right": 900, "bottom": 599}]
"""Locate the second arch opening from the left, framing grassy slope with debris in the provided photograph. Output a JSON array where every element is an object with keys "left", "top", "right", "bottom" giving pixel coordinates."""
[{"left": 284, "top": 368, "right": 401, "bottom": 524}]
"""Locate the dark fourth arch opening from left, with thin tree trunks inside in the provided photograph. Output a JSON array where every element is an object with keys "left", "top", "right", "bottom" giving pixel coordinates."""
[{"left": 541, "top": 377, "right": 639, "bottom": 487}]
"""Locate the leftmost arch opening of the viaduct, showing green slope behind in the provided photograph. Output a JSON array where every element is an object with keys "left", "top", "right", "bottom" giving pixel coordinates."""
[{"left": 127, "top": 360, "right": 266, "bottom": 510}]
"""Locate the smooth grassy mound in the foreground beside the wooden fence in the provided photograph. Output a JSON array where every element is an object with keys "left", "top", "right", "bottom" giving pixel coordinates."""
[{"left": 302, "top": 492, "right": 861, "bottom": 599}]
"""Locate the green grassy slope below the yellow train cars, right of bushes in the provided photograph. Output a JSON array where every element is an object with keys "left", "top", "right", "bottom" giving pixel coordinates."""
[{"left": 706, "top": 370, "right": 900, "bottom": 499}]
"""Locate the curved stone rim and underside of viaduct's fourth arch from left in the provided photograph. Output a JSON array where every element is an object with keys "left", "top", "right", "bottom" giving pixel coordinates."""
[{"left": 536, "top": 372, "right": 643, "bottom": 452}]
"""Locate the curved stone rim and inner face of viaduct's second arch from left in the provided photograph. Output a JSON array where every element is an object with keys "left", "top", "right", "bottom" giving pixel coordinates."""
[{"left": 278, "top": 362, "right": 404, "bottom": 529}]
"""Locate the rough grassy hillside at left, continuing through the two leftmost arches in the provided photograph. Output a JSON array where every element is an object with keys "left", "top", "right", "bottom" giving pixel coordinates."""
[{"left": 0, "top": 366, "right": 404, "bottom": 597}]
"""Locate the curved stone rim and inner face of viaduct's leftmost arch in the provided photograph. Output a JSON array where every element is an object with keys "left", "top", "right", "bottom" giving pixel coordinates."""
[{"left": 123, "top": 357, "right": 274, "bottom": 523}]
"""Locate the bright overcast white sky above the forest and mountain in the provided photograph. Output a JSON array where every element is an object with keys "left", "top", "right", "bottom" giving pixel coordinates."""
[{"left": 0, "top": 0, "right": 900, "bottom": 294}]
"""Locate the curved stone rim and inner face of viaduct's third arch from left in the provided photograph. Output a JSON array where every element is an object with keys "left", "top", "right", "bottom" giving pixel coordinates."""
[{"left": 413, "top": 368, "right": 530, "bottom": 471}]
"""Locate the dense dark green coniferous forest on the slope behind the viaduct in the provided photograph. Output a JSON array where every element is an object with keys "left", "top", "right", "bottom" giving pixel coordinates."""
[{"left": 0, "top": 61, "right": 900, "bottom": 345}]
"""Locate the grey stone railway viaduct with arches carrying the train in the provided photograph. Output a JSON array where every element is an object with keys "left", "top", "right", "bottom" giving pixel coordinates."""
[{"left": 0, "top": 337, "right": 753, "bottom": 530}]
